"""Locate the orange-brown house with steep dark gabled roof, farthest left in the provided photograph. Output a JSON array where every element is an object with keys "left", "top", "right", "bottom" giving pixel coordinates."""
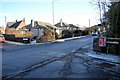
[{"left": 5, "top": 18, "right": 32, "bottom": 37}]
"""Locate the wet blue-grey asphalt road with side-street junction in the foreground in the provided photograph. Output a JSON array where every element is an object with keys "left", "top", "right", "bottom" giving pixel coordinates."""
[{"left": 2, "top": 36, "right": 118, "bottom": 78}]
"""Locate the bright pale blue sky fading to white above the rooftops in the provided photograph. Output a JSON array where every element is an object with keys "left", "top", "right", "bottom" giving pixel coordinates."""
[{"left": 0, "top": 0, "right": 99, "bottom": 27}]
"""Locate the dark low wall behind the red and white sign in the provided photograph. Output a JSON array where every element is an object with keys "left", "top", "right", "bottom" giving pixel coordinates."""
[{"left": 93, "top": 38, "right": 120, "bottom": 55}]
